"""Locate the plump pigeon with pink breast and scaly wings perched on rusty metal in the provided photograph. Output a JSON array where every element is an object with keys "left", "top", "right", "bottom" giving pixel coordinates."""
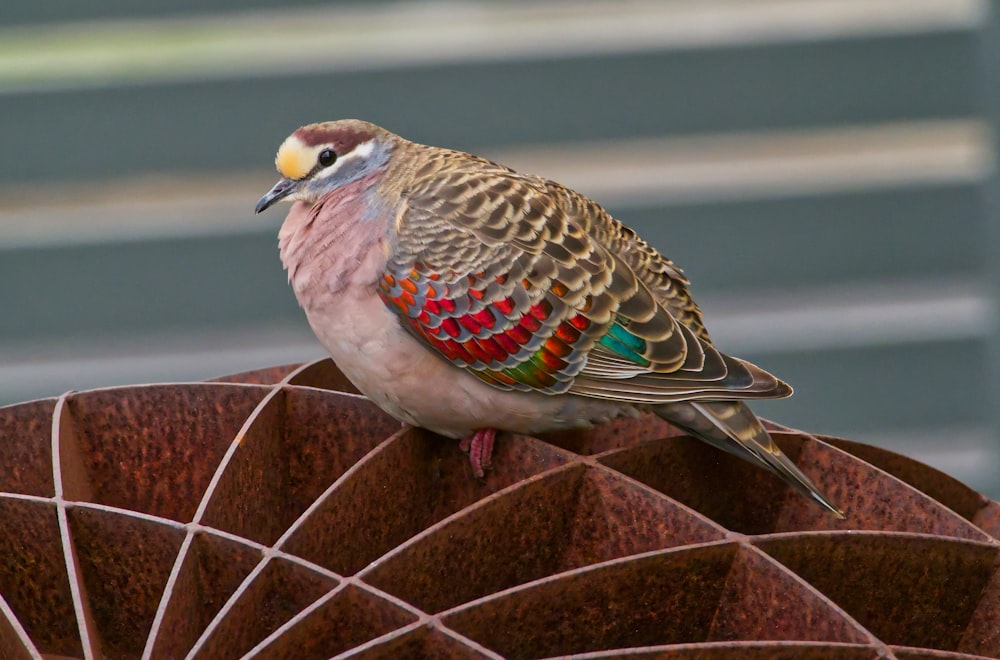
[{"left": 255, "top": 119, "right": 844, "bottom": 518}]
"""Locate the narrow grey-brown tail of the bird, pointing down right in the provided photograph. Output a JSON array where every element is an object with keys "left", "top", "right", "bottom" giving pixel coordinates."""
[{"left": 653, "top": 401, "right": 844, "bottom": 518}]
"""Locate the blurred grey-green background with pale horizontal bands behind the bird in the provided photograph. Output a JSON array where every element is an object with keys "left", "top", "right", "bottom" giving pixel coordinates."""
[{"left": 0, "top": 0, "right": 1000, "bottom": 498}]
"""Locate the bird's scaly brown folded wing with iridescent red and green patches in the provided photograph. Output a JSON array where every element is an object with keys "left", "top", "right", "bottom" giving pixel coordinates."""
[{"left": 379, "top": 152, "right": 790, "bottom": 404}]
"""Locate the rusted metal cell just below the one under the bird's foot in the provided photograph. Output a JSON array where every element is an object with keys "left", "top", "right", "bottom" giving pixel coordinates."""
[{"left": 362, "top": 465, "right": 722, "bottom": 612}]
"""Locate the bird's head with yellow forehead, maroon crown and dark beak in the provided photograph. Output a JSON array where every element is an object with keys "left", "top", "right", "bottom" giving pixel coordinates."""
[{"left": 256, "top": 119, "right": 395, "bottom": 213}]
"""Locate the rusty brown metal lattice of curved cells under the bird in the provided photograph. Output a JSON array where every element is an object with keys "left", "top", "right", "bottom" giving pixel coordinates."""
[{"left": 0, "top": 360, "right": 1000, "bottom": 660}]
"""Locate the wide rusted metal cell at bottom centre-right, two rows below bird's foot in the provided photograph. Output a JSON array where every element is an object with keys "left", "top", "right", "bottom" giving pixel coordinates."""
[{"left": 442, "top": 543, "right": 868, "bottom": 658}]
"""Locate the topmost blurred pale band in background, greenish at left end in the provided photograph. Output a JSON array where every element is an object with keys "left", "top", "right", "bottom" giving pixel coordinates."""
[{"left": 0, "top": 0, "right": 987, "bottom": 93}]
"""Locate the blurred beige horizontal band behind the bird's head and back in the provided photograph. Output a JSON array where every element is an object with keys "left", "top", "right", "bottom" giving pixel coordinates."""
[{"left": 0, "top": 120, "right": 993, "bottom": 249}]
